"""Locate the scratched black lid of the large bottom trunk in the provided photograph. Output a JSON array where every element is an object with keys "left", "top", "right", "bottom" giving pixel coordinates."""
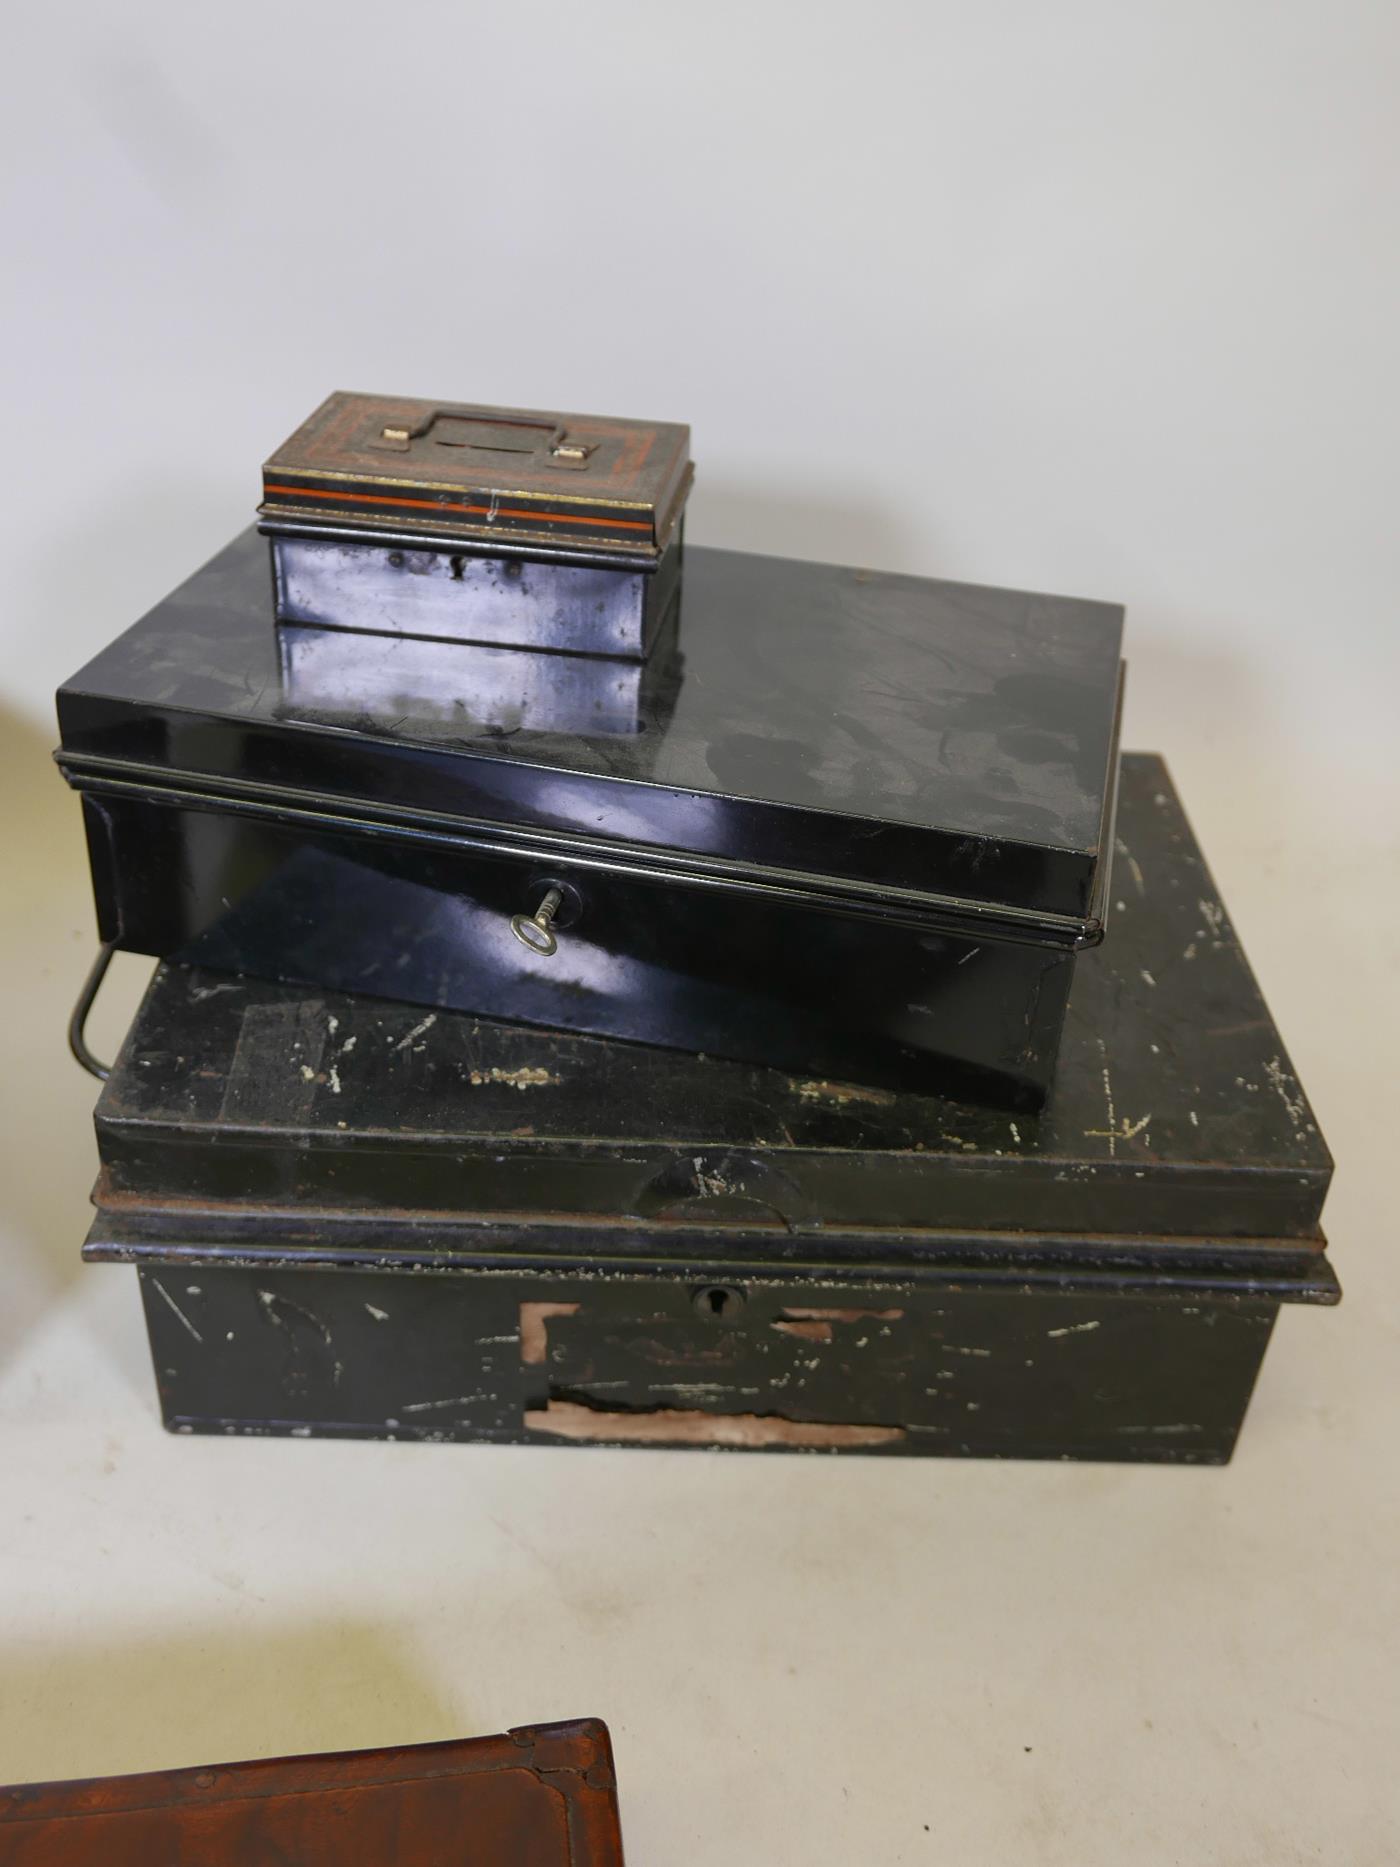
[{"left": 88, "top": 754, "right": 1335, "bottom": 1299}]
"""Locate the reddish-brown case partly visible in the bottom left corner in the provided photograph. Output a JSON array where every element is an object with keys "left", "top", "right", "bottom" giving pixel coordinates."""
[{"left": 0, "top": 1718, "right": 622, "bottom": 1867}]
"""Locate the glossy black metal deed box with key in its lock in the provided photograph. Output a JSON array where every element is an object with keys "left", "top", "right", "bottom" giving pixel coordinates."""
[{"left": 58, "top": 530, "right": 1122, "bottom": 1107}]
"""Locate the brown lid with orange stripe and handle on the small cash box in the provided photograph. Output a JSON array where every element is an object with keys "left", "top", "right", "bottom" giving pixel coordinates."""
[{"left": 258, "top": 390, "right": 694, "bottom": 560}]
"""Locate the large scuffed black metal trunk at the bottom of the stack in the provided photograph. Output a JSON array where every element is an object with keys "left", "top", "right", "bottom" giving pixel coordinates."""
[{"left": 86, "top": 756, "right": 1338, "bottom": 1464}]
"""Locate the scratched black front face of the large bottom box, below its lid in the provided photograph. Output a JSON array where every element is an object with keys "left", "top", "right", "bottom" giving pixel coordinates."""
[{"left": 126, "top": 1258, "right": 1279, "bottom": 1464}]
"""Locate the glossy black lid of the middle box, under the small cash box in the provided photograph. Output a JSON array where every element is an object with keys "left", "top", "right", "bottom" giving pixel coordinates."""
[{"left": 60, "top": 530, "right": 1122, "bottom": 945}]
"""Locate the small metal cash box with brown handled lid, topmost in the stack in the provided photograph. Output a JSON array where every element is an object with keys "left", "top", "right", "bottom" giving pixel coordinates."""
[{"left": 258, "top": 394, "right": 694, "bottom": 657}]
